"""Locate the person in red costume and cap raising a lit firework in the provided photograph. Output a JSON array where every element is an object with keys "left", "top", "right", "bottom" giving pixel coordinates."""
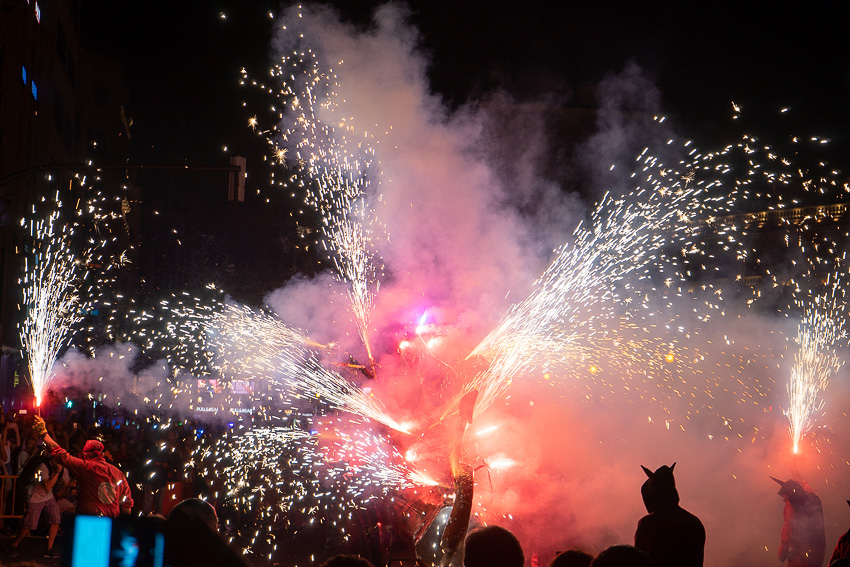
[{"left": 33, "top": 416, "right": 133, "bottom": 518}]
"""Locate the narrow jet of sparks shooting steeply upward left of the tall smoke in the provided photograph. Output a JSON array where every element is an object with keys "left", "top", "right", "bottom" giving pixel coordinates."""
[{"left": 243, "top": 40, "right": 380, "bottom": 372}]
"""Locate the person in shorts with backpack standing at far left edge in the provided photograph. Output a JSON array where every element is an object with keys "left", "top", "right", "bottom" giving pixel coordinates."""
[{"left": 9, "top": 448, "right": 64, "bottom": 558}]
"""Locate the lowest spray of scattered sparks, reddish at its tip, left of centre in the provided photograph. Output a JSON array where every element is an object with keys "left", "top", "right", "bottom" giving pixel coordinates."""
[{"left": 193, "top": 426, "right": 436, "bottom": 559}]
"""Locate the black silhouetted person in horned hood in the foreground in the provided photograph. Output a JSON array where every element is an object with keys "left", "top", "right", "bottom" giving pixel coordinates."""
[{"left": 635, "top": 463, "right": 705, "bottom": 567}]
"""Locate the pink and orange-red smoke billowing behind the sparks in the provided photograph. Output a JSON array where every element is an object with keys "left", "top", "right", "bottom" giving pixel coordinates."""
[{"left": 55, "top": 4, "right": 850, "bottom": 567}]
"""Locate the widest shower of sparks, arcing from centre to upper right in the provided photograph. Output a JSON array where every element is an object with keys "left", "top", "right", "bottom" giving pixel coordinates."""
[{"left": 458, "top": 122, "right": 848, "bottom": 428}]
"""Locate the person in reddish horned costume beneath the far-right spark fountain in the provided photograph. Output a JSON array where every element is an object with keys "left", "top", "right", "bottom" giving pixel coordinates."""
[{"left": 770, "top": 477, "right": 826, "bottom": 567}]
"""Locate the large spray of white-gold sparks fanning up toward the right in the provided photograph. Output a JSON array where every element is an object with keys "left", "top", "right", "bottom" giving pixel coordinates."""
[{"left": 458, "top": 120, "right": 848, "bottom": 421}]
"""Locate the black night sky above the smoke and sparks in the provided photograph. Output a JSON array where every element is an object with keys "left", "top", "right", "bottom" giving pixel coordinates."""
[{"left": 83, "top": 0, "right": 850, "bottom": 150}]
